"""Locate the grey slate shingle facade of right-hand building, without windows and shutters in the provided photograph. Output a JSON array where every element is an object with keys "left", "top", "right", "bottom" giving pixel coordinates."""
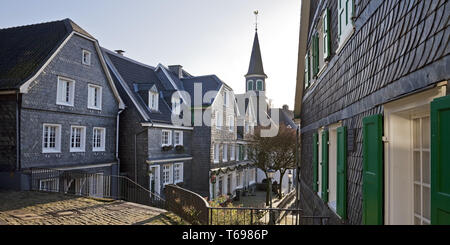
[{"left": 300, "top": 0, "right": 450, "bottom": 224}]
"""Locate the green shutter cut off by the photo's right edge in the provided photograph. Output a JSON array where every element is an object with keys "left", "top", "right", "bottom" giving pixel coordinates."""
[{"left": 431, "top": 96, "right": 450, "bottom": 225}]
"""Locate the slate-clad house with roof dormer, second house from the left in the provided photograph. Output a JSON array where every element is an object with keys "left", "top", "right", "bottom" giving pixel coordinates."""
[{"left": 103, "top": 49, "right": 197, "bottom": 196}]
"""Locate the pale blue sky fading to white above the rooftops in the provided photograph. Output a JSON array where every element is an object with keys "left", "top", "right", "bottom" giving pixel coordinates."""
[{"left": 0, "top": 0, "right": 300, "bottom": 109}]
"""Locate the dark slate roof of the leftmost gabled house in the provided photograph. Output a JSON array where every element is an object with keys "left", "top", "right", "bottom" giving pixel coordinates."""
[{"left": 0, "top": 19, "right": 94, "bottom": 90}]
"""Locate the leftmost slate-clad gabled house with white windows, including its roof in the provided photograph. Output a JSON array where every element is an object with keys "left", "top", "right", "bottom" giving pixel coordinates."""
[{"left": 0, "top": 19, "right": 124, "bottom": 196}]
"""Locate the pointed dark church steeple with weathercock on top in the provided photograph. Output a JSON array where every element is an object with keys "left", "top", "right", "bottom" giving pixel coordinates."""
[{"left": 245, "top": 11, "right": 267, "bottom": 92}]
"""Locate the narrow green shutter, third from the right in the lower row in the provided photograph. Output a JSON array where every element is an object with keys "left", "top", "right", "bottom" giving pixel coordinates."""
[{"left": 336, "top": 127, "right": 347, "bottom": 219}]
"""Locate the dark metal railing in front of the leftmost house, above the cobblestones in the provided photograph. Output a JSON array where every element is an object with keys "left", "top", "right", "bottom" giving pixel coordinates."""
[{"left": 31, "top": 168, "right": 165, "bottom": 209}]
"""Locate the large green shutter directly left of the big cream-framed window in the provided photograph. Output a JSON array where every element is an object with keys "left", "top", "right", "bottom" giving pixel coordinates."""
[{"left": 363, "top": 115, "right": 383, "bottom": 225}]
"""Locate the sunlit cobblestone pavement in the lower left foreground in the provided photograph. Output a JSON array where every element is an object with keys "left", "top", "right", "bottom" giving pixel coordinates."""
[{"left": 0, "top": 191, "right": 183, "bottom": 225}]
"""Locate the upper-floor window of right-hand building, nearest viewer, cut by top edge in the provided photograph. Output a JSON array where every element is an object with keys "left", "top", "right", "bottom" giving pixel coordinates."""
[{"left": 338, "top": 0, "right": 354, "bottom": 50}]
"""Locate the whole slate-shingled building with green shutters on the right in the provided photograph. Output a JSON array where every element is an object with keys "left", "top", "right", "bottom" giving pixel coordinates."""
[{"left": 295, "top": 0, "right": 450, "bottom": 225}]
